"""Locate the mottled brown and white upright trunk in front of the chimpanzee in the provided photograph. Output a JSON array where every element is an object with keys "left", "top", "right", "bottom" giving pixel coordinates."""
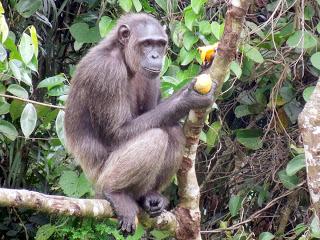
[{"left": 175, "top": 0, "right": 251, "bottom": 240}]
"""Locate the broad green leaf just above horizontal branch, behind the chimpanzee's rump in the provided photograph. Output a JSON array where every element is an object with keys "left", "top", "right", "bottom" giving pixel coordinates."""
[{"left": 59, "top": 171, "right": 91, "bottom": 197}]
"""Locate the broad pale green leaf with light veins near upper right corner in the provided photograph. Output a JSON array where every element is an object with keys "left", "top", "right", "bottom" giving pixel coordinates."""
[{"left": 287, "top": 31, "right": 317, "bottom": 49}]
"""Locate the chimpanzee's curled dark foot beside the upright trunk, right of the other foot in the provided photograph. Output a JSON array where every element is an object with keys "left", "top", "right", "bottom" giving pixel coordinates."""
[{"left": 140, "top": 192, "right": 169, "bottom": 217}]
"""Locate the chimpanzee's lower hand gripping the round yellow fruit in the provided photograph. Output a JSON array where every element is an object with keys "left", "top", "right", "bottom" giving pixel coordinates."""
[{"left": 180, "top": 79, "right": 215, "bottom": 109}]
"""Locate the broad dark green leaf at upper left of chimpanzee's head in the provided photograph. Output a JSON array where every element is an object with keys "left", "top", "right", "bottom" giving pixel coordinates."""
[{"left": 70, "top": 22, "right": 101, "bottom": 43}]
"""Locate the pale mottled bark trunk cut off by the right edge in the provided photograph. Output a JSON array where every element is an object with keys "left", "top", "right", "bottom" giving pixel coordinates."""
[{"left": 299, "top": 77, "right": 320, "bottom": 210}]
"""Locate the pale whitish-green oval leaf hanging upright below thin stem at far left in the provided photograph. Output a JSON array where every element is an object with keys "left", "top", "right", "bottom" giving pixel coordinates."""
[{"left": 20, "top": 103, "right": 37, "bottom": 138}]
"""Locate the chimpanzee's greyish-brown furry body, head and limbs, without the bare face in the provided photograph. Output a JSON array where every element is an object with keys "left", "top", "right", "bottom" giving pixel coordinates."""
[{"left": 65, "top": 14, "right": 211, "bottom": 236}]
